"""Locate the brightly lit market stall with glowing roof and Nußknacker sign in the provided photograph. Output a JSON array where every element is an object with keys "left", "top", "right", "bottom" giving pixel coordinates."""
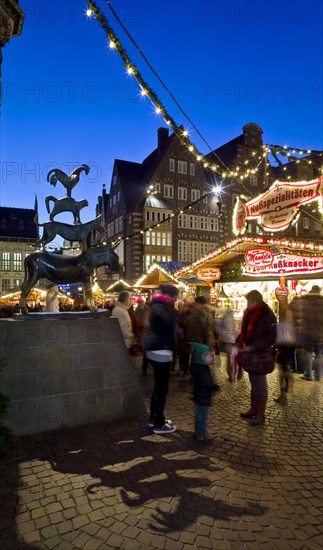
[{"left": 176, "top": 236, "right": 323, "bottom": 323}]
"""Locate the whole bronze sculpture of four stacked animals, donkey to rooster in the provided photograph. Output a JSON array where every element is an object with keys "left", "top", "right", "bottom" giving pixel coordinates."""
[{"left": 19, "top": 164, "right": 122, "bottom": 313}]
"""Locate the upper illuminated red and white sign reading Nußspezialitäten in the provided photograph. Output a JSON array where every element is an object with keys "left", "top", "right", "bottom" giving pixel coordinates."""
[{"left": 233, "top": 177, "right": 323, "bottom": 234}]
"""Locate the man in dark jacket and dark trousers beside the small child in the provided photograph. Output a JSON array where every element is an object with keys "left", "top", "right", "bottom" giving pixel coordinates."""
[{"left": 146, "top": 284, "right": 178, "bottom": 434}]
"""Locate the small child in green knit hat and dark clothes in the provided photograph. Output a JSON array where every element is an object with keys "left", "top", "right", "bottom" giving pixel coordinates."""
[{"left": 189, "top": 342, "right": 220, "bottom": 443}]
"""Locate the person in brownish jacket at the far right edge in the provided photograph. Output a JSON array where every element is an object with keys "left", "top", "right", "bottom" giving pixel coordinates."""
[{"left": 290, "top": 285, "right": 323, "bottom": 380}]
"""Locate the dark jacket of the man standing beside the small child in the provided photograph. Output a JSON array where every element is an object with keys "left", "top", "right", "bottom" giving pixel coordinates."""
[{"left": 146, "top": 294, "right": 176, "bottom": 351}]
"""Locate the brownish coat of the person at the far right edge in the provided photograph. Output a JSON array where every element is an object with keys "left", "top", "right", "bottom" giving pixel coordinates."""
[{"left": 290, "top": 292, "right": 323, "bottom": 347}]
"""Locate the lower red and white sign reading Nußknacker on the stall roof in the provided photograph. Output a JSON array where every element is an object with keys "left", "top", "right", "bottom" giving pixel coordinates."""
[{"left": 243, "top": 254, "right": 323, "bottom": 277}]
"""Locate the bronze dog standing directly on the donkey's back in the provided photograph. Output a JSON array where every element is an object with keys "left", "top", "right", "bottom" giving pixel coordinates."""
[{"left": 37, "top": 216, "right": 103, "bottom": 250}]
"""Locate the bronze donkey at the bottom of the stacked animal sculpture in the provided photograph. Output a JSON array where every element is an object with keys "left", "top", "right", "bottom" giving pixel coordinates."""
[{"left": 19, "top": 245, "right": 123, "bottom": 313}]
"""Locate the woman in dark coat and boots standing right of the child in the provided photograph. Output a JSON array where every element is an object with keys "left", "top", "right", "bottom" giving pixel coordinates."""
[{"left": 236, "top": 290, "right": 276, "bottom": 426}]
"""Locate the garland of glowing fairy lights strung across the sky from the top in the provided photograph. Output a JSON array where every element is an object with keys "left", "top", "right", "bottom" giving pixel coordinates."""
[{"left": 86, "top": 0, "right": 323, "bottom": 182}]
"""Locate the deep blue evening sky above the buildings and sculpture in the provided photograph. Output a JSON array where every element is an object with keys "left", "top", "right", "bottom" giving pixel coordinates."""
[{"left": 0, "top": 0, "right": 323, "bottom": 226}]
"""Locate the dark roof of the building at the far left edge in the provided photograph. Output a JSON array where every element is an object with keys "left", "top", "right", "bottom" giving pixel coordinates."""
[{"left": 0, "top": 206, "right": 39, "bottom": 239}]
